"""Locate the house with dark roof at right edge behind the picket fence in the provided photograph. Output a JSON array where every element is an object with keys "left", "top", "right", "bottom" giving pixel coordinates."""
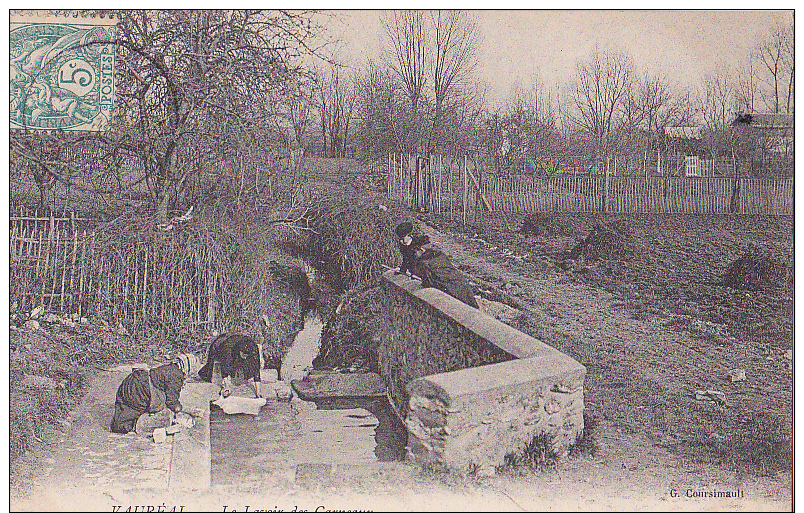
[{"left": 732, "top": 112, "right": 795, "bottom": 178}]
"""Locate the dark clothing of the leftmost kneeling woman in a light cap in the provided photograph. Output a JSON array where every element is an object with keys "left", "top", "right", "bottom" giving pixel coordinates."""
[{"left": 111, "top": 363, "right": 184, "bottom": 433}]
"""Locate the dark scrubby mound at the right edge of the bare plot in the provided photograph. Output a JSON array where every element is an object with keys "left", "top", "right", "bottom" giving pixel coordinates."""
[{"left": 721, "top": 244, "right": 793, "bottom": 291}]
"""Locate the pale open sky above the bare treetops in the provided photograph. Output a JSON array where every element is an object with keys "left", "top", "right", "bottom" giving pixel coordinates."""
[{"left": 318, "top": 10, "right": 793, "bottom": 103}]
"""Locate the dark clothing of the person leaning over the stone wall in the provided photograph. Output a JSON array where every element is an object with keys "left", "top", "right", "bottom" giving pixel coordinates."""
[{"left": 399, "top": 235, "right": 479, "bottom": 308}]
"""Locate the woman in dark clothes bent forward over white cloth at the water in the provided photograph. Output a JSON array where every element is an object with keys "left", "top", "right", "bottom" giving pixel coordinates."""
[{"left": 198, "top": 333, "right": 262, "bottom": 398}]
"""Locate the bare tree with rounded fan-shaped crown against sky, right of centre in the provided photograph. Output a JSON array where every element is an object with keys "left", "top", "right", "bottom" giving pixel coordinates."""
[{"left": 570, "top": 51, "right": 634, "bottom": 159}]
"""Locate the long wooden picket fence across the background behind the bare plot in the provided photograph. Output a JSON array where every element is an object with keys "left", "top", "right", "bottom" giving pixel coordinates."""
[{"left": 387, "top": 154, "right": 793, "bottom": 216}]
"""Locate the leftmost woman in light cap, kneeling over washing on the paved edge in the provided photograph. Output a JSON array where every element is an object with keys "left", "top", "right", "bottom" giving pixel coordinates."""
[{"left": 111, "top": 358, "right": 190, "bottom": 435}]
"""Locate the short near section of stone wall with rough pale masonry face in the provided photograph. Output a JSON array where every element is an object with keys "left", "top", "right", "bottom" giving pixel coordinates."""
[{"left": 405, "top": 358, "right": 586, "bottom": 472}]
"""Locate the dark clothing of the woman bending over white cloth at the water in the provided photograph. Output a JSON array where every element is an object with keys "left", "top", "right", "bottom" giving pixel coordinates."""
[{"left": 198, "top": 333, "right": 261, "bottom": 383}]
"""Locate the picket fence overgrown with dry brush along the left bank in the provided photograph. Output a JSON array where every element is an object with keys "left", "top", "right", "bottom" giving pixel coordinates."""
[{"left": 11, "top": 205, "right": 310, "bottom": 339}]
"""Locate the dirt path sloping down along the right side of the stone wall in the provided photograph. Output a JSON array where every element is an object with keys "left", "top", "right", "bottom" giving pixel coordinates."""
[{"left": 419, "top": 223, "right": 792, "bottom": 500}]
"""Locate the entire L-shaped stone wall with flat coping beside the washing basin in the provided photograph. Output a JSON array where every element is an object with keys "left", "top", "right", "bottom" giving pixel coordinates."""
[{"left": 377, "top": 271, "right": 586, "bottom": 472}]
